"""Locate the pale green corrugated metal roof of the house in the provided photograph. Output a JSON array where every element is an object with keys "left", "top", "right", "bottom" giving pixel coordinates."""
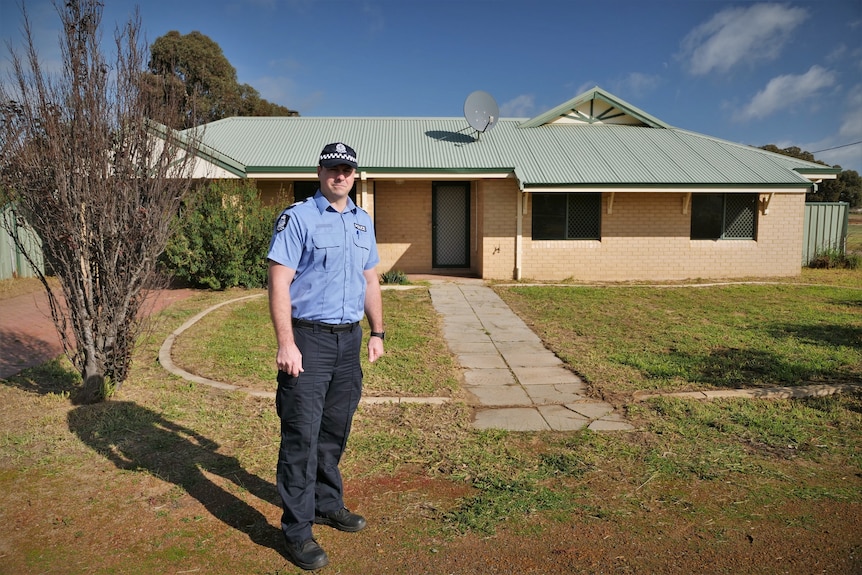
[{"left": 187, "top": 88, "right": 838, "bottom": 189}]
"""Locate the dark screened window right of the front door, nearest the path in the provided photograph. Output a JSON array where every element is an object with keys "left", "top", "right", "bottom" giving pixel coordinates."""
[{"left": 533, "top": 193, "right": 602, "bottom": 240}]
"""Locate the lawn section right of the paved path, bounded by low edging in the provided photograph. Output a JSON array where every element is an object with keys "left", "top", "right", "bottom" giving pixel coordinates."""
[{"left": 498, "top": 270, "right": 862, "bottom": 400}]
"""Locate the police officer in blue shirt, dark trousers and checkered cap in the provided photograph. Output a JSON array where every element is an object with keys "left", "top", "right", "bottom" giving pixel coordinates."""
[{"left": 267, "top": 142, "right": 384, "bottom": 570}]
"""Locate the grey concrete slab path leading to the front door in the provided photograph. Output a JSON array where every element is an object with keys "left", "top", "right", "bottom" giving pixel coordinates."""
[{"left": 430, "top": 280, "right": 633, "bottom": 431}]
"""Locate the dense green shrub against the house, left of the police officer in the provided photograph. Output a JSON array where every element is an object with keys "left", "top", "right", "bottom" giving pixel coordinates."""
[{"left": 162, "top": 180, "right": 281, "bottom": 290}]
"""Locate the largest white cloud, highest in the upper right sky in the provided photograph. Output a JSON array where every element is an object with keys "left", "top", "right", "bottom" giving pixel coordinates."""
[{"left": 680, "top": 4, "right": 808, "bottom": 75}]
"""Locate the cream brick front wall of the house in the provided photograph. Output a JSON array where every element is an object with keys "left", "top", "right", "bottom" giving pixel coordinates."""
[{"left": 253, "top": 179, "right": 805, "bottom": 281}]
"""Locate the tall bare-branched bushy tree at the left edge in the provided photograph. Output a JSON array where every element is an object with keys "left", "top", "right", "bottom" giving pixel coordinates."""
[{"left": 0, "top": 0, "right": 199, "bottom": 402}]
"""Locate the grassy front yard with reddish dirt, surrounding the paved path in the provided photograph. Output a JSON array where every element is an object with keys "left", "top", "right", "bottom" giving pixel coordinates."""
[{"left": 0, "top": 270, "right": 862, "bottom": 575}]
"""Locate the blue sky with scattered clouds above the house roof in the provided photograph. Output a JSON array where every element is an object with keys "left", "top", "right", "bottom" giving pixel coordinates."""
[{"left": 0, "top": 0, "right": 862, "bottom": 173}]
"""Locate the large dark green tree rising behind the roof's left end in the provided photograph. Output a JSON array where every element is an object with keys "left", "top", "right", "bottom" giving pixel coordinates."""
[{"left": 149, "top": 30, "right": 299, "bottom": 128}]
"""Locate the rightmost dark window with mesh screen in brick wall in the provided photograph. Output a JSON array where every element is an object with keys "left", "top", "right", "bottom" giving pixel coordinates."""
[{"left": 691, "top": 194, "right": 758, "bottom": 240}]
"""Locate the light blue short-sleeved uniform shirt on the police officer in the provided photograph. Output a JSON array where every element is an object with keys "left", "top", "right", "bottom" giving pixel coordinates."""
[{"left": 267, "top": 190, "right": 380, "bottom": 324}]
